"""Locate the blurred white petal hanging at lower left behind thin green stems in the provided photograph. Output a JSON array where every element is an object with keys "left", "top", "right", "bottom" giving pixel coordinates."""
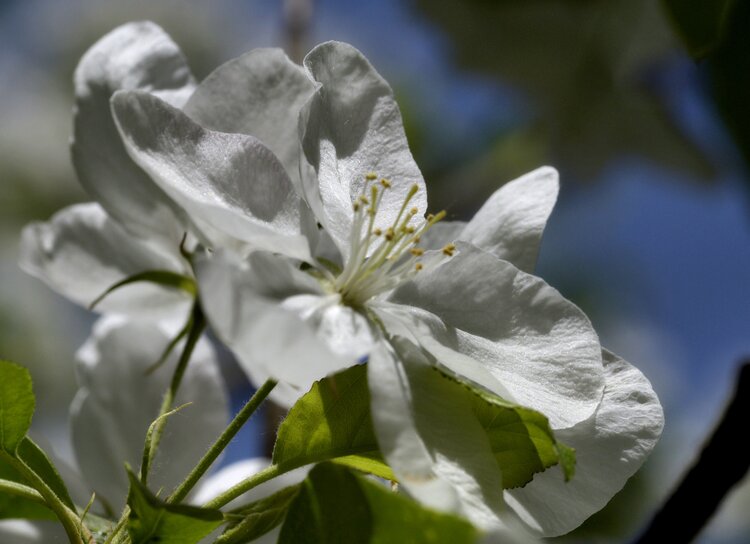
[{"left": 71, "top": 318, "right": 229, "bottom": 511}]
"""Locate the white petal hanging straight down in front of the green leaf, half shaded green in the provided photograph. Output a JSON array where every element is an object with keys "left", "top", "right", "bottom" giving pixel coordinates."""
[{"left": 367, "top": 340, "right": 504, "bottom": 529}]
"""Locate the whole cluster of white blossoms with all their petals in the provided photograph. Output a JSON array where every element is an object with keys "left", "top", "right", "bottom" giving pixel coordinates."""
[{"left": 4, "top": 22, "right": 663, "bottom": 541}]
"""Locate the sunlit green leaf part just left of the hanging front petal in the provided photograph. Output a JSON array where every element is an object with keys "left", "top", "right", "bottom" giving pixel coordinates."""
[{"left": 273, "top": 365, "right": 393, "bottom": 479}]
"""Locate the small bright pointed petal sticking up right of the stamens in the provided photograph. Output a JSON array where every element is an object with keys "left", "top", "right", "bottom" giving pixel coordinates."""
[{"left": 457, "top": 166, "right": 560, "bottom": 272}]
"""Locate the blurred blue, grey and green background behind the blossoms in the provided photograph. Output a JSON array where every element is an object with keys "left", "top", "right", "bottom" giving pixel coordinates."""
[{"left": 0, "top": 0, "right": 750, "bottom": 543}]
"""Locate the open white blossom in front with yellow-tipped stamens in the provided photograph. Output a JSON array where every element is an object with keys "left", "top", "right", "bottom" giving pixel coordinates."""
[{"left": 114, "top": 43, "right": 662, "bottom": 535}]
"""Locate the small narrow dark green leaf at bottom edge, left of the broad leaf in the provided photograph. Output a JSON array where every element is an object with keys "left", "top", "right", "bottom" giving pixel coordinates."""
[{"left": 215, "top": 485, "right": 300, "bottom": 544}]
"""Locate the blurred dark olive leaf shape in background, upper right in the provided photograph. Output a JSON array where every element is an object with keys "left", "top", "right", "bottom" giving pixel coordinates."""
[{"left": 417, "top": 0, "right": 714, "bottom": 186}]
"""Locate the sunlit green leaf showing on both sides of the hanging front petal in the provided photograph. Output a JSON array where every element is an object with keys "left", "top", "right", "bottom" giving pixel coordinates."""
[{"left": 273, "top": 365, "right": 575, "bottom": 489}]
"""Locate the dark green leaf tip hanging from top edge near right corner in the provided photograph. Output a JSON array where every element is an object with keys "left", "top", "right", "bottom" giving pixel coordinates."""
[{"left": 662, "top": 0, "right": 735, "bottom": 59}]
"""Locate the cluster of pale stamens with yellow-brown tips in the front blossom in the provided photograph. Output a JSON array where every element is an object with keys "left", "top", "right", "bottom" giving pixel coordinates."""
[{"left": 333, "top": 174, "right": 456, "bottom": 306}]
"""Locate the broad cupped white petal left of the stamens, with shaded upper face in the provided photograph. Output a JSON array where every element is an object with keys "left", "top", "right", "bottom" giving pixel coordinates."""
[{"left": 112, "top": 91, "right": 309, "bottom": 259}]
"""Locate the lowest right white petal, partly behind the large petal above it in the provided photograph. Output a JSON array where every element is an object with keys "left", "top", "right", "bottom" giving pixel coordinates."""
[{"left": 506, "top": 351, "right": 664, "bottom": 536}]
